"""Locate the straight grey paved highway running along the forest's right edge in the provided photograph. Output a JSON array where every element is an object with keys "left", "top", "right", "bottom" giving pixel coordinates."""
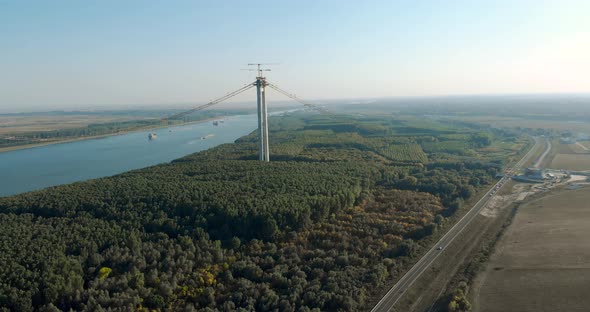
[{"left": 371, "top": 138, "right": 541, "bottom": 312}]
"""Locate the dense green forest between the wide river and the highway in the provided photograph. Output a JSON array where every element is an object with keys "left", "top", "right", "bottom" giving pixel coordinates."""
[{"left": 0, "top": 114, "right": 527, "bottom": 311}]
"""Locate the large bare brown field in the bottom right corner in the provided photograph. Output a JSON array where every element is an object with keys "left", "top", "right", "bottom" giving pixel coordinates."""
[{"left": 472, "top": 186, "right": 590, "bottom": 312}]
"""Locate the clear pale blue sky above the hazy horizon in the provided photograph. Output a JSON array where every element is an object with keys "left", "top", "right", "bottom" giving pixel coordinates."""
[{"left": 0, "top": 0, "right": 590, "bottom": 111}]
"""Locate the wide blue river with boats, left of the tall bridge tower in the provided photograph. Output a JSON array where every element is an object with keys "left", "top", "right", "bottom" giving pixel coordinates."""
[{"left": 0, "top": 115, "right": 257, "bottom": 196}]
